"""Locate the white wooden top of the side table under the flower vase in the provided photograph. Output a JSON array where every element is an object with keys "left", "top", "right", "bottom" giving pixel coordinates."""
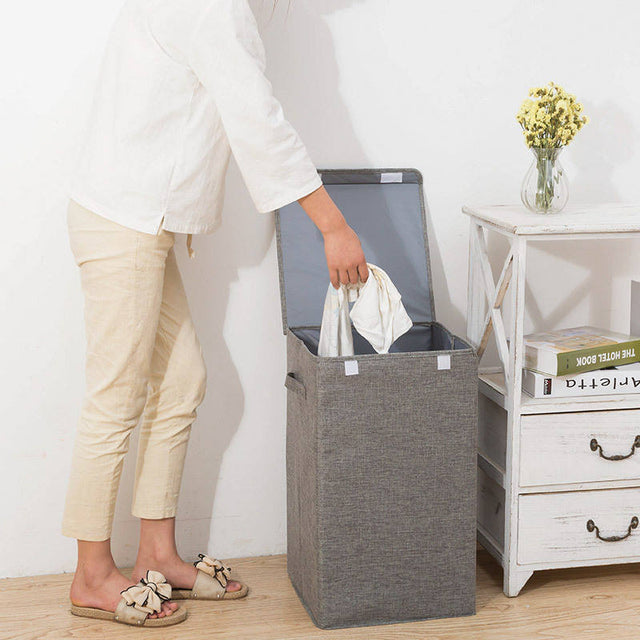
[{"left": 462, "top": 202, "right": 640, "bottom": 235}]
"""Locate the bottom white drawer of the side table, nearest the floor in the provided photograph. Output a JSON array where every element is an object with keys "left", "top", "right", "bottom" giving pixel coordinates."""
[{"left": 518, "top": 488, "right": 640, "bottom": 564}]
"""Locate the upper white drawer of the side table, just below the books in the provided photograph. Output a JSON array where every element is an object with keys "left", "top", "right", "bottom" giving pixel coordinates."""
[{"left": 520, "top": 409, "right": 640, "bottom": 487}]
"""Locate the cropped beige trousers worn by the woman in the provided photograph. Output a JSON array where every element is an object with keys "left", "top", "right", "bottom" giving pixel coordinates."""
[{"left": 62, "top": 200, "right": 206, "bottom": 540}]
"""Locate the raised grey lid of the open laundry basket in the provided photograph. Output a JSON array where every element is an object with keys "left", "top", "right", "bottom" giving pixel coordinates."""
[{"left": 276, "top": 169, "right": 435, "bottom": 333}]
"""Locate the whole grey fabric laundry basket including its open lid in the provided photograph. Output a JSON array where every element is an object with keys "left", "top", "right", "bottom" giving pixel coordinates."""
[{"left": 276, "top": 169, "right": 477, "bottom": 628}]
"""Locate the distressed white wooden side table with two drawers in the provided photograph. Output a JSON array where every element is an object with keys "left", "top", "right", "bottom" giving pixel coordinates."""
[{"left": 462, "top": 204, "right": 640, "bottom": 596}]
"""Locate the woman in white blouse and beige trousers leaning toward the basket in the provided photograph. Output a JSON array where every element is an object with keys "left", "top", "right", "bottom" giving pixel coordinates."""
[{"left": 62, "top": 0, "right": 368, "bottom": 626}]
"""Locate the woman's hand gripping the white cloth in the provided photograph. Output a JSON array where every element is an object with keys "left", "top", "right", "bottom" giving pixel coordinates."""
[{"left": 323, "top": 222, "right": 369, "bottom": 289}]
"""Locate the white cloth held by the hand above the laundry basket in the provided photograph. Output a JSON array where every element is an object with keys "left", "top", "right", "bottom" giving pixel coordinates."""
[{"left": 318, "top": 263, "right": 413, "bottom": 357}]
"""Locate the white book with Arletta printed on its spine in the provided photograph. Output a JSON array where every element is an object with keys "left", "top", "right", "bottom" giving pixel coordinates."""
[{"left": 522, "top": 362, "right": 640, "bottom": 398}]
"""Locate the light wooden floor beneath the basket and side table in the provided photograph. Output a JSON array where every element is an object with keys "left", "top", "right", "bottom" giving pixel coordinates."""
[{"left": 0, "top": 551, "right": 640, "bottom": 640}]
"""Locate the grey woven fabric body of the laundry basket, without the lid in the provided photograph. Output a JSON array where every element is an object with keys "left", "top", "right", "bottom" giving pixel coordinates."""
[{"left": 287, "top": 332, "right": 477, "bottom": 628}]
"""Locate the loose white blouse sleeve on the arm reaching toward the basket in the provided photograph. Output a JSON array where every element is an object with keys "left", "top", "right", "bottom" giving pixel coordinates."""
[{"left": 188, "top": 0, "right": 322, "bottom": 213}]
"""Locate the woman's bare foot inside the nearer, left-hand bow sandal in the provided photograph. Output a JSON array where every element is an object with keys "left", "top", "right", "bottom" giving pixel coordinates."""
[{"left": 70, "top": 566, "right": 178, "bottom": 618}]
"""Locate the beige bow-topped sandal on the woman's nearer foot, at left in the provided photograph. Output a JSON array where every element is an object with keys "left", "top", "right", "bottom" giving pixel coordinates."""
[{"left": 71, "top": 571, "right": 187, "bottom": 627}]
